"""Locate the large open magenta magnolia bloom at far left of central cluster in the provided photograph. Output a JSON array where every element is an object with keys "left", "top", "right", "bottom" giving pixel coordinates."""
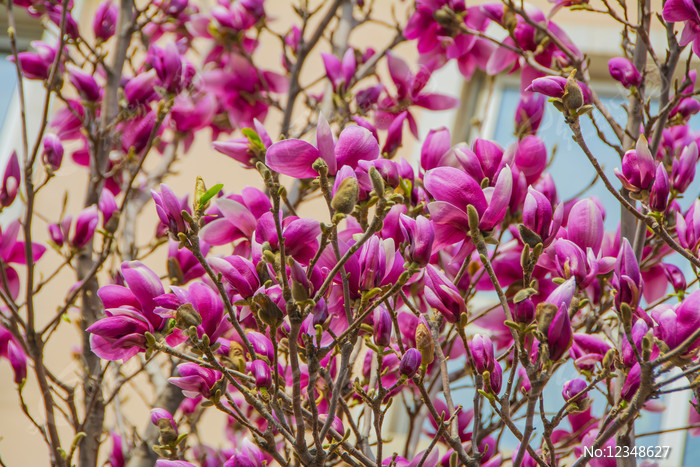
[{"left": 87, "top": 261, "right": 172, "bottom": 361}]
